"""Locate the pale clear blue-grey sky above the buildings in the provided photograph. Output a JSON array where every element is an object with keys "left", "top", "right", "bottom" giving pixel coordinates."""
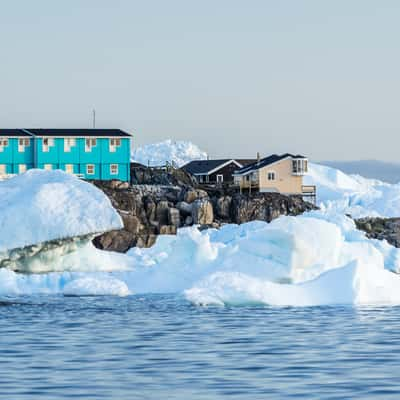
[{"left": 0, "top": 0, "right": 400, "bottom": 161}]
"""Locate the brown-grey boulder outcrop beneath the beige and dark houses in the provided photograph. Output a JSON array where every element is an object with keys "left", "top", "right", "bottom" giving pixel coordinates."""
[{"left": 93, "top": 179, "right": 315, "bottom": 252}]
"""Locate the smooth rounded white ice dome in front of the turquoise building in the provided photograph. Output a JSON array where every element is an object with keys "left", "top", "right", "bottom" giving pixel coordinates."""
[{"left": 0, "top": 169, "right": 122, "bottom": 252}]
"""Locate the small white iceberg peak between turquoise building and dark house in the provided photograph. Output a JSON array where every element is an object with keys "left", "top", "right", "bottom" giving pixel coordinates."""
[{"left": 132, "top": 139, "right": 207, "bottom": 167}]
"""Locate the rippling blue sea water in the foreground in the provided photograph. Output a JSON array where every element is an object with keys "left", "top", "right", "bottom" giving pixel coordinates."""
[{"left": 0, "top": 295, "right": 400, "bottom": 400}]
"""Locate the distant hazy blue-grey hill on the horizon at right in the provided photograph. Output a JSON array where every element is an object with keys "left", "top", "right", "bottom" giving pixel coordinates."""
[{"left": 318, "top": 160, "right": 400, "bottom": 183}]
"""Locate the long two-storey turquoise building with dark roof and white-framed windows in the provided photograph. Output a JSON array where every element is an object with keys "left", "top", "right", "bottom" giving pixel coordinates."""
[{"left": 0, "top": 129, "right": 132, "bottom": 182}]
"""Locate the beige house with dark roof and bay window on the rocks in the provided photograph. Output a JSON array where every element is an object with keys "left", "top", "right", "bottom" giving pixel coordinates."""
[{"left": 233, "top": 153, "right": 315, "bottom": 197}]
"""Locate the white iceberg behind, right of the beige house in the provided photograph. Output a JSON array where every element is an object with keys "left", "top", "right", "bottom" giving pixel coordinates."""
[{"left": 304, "top": 163, "right": 400, "bottom": 218}]
